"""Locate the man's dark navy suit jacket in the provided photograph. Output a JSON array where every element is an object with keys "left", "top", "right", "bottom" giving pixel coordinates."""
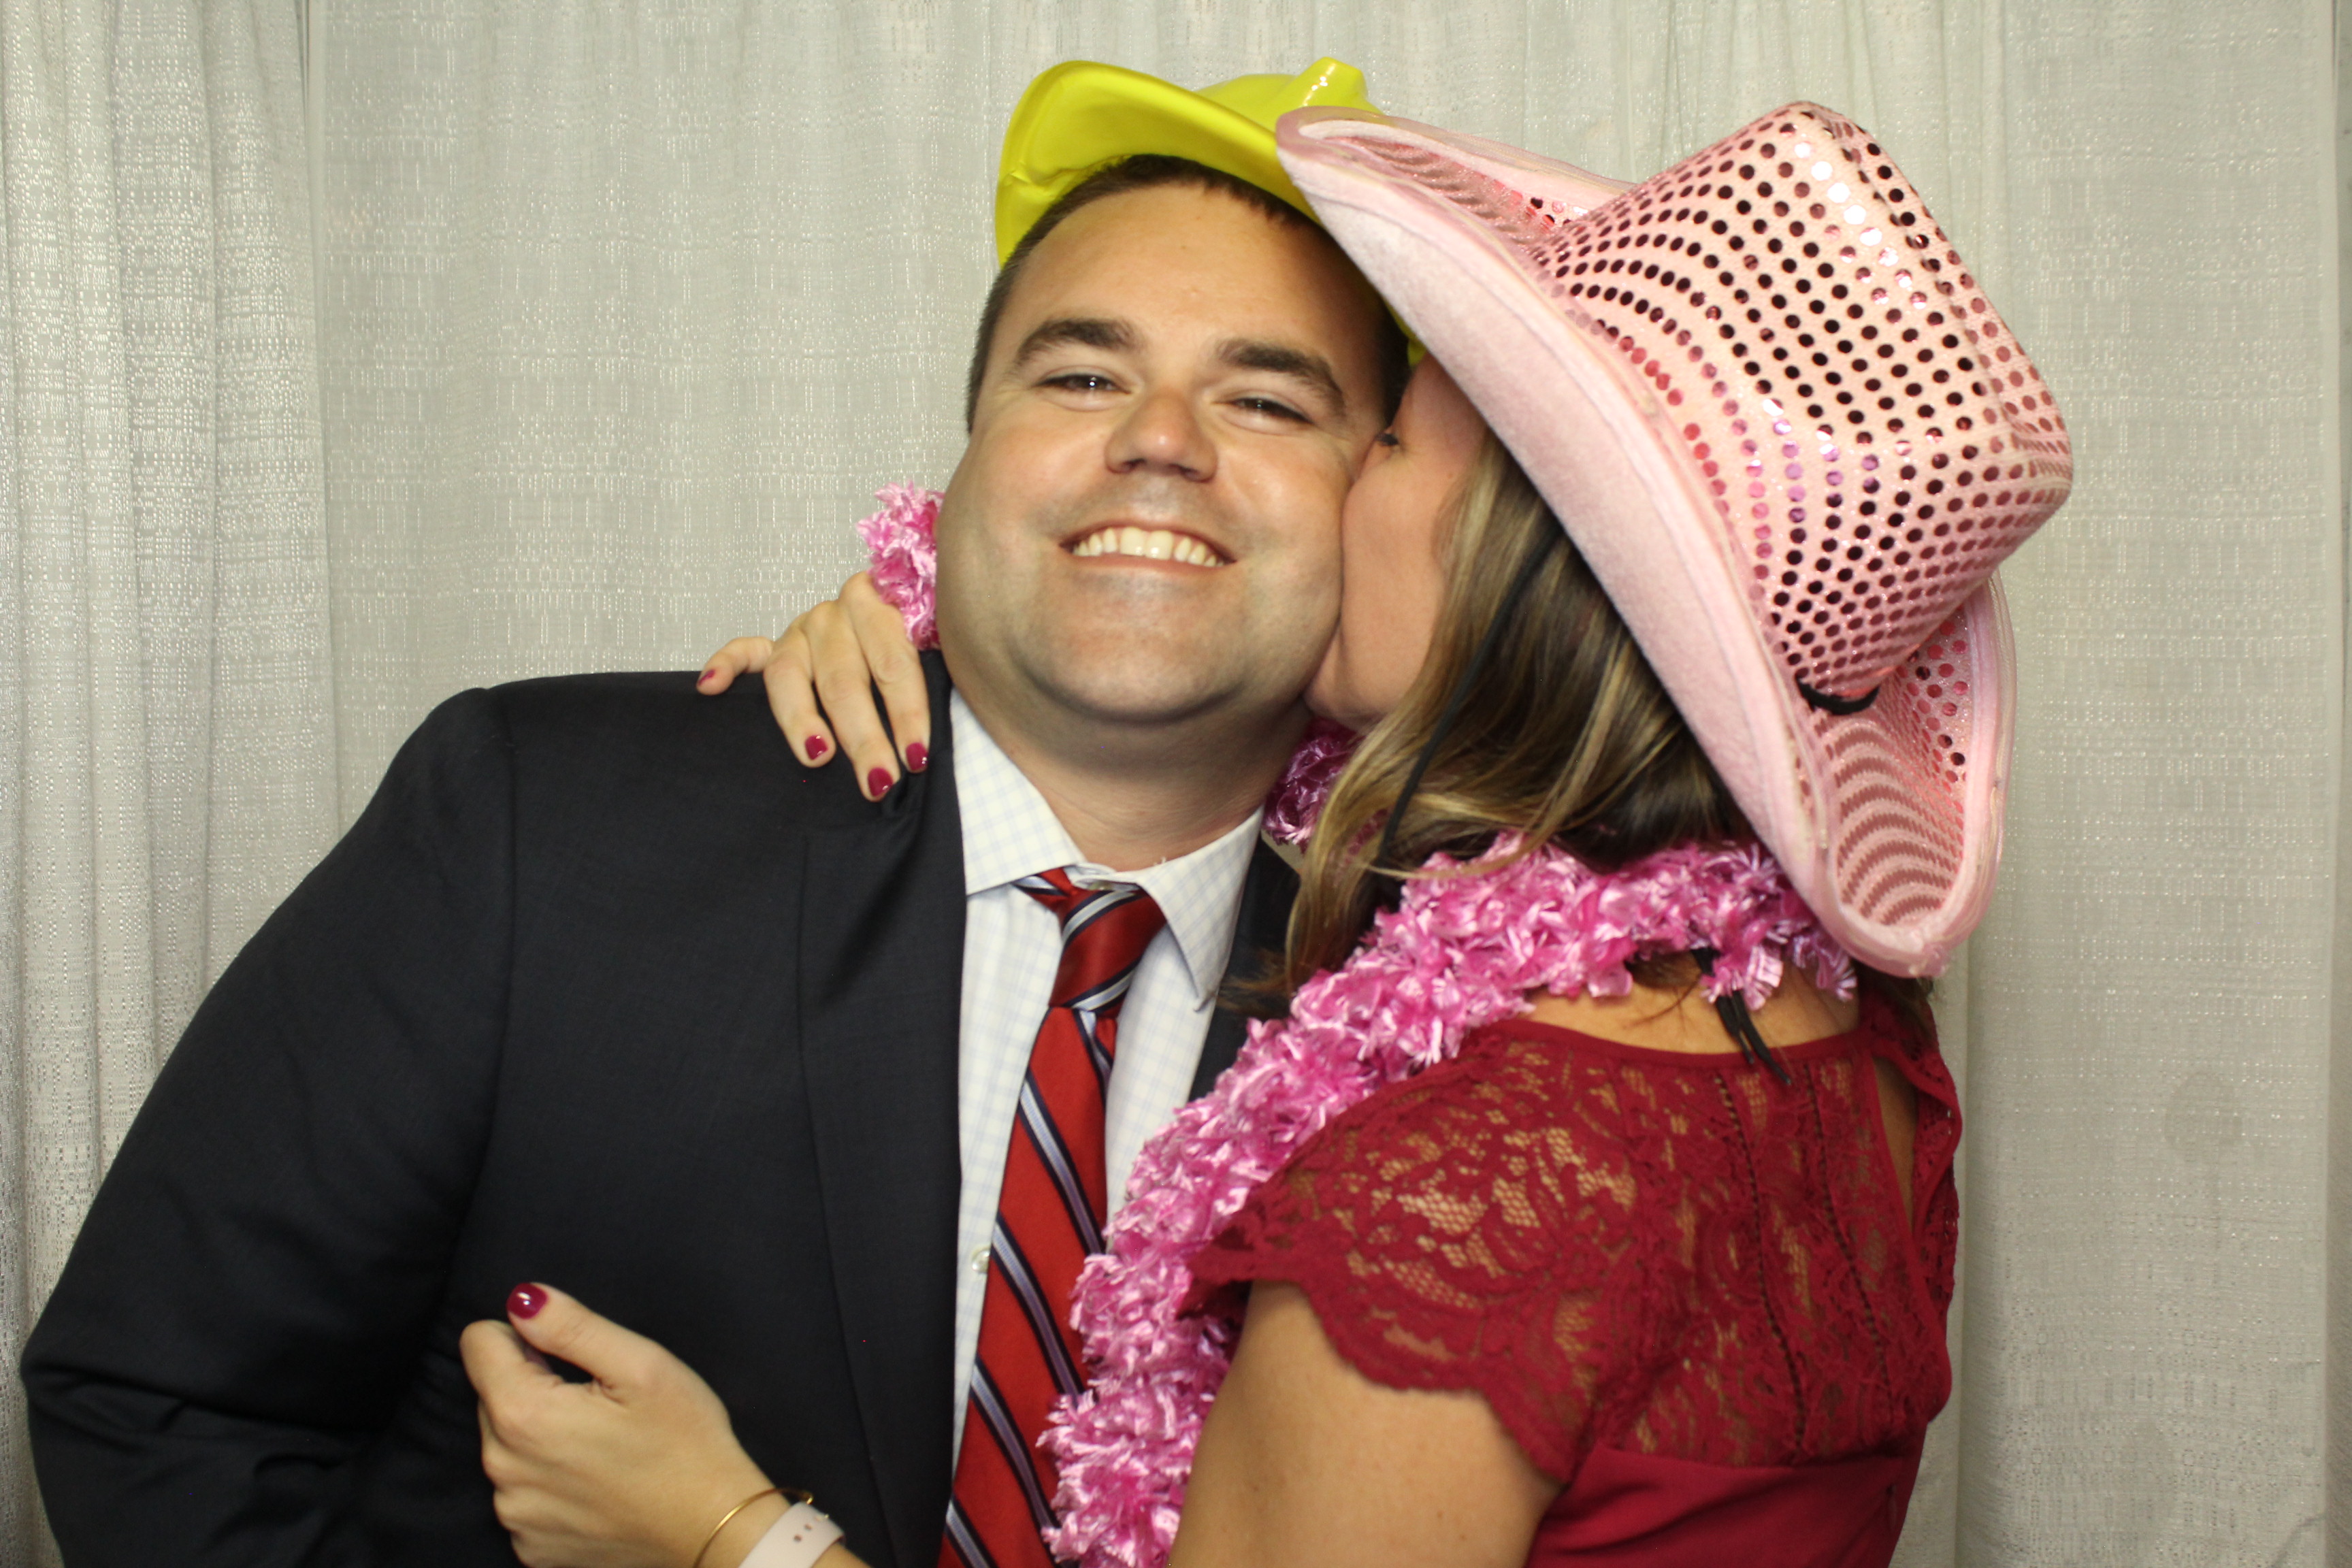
[{"left": 24, "top": 656, "right": 1296, "bottom": 1568}]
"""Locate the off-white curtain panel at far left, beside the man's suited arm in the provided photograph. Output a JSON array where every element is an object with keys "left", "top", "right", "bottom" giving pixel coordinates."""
[{"left": 0, "top": 0, "right": 336, "bottom": 1563}]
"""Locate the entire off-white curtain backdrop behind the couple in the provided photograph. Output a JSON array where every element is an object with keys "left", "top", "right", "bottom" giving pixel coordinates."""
[{"left": 0, "top": 0, "right": 2352, "bottom": 1568}]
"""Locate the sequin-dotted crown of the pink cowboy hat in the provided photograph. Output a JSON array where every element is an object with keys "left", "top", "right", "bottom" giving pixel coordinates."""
[{"left": 1357, "top": 103, "right": 2072, "bottom": 703}]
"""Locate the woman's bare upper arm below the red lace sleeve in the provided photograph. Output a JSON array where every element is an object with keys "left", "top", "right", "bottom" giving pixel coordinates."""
[{"left": 1169, "top": 1281, "right": 1559, "bottom": 1568}]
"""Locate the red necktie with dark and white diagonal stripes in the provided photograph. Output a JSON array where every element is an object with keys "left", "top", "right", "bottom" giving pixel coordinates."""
[{"left": 938, "top": 870, "right": 1166, "bottom": 1568}]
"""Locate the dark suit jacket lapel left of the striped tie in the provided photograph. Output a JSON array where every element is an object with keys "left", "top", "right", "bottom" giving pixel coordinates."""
[{"left": 800, "top": 656, "right": 964, "bottom": 1568}]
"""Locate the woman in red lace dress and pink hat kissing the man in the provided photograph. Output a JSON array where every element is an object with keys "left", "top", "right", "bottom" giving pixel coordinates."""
[{"left": 454, "top": 95, "right": 2070, "bottom": 1568}]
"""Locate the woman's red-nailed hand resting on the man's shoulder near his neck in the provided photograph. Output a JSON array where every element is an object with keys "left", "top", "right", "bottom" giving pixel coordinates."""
[{"left": 696, "top": 571, "right": 932, "bottom": 799}]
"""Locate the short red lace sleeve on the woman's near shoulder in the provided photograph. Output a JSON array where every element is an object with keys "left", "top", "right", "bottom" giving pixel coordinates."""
[{"left": 1192, "top": 1044, "right": 1682, "bottom": 1484}]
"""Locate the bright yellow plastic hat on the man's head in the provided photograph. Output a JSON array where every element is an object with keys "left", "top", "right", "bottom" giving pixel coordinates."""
[{"left": 997, "top": 56, "right": 1378, "bottom": 265}]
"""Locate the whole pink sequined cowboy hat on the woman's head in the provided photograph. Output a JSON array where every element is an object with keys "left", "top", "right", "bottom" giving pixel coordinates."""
[{"left": 1279, "top": 103, "right": 2072, "bottom": 976}]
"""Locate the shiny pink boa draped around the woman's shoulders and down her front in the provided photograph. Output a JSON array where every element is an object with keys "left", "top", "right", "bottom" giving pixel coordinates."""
[{"left": 1044, "top": 847, "right": 1853, "bottom": 1568}]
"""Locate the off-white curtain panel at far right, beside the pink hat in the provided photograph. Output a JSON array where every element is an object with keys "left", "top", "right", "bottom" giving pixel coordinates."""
[{"left": 1959, "top": 2, "right": 2345, "bottom": 1563}]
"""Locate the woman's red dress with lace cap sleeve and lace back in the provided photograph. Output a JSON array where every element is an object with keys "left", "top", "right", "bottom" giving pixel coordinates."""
[{"left": 1192, "top": 999, "right": 1959, "bottom": 1568}]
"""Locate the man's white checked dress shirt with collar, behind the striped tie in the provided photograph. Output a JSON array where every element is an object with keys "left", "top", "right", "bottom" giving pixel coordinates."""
[{"left": 948, "top": 693, "right": 1258, "bottom": 1443}]
